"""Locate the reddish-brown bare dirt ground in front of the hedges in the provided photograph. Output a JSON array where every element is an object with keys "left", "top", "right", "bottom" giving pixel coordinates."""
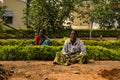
[{"left": 0, "top": 61, "right": 120, "bottom": 80}]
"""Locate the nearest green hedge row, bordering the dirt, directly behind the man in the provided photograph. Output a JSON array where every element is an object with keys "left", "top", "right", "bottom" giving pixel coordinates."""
[{"left": 0, "top": 45, "right": 120, "bottom": 60}]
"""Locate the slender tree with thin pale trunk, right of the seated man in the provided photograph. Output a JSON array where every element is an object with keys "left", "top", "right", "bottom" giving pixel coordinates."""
[{"left": 76, "top": 1, "right": 95, "bottom": 39}]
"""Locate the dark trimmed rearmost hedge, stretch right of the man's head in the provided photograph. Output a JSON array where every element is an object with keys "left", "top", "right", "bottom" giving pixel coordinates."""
[{"left": 76, "top": 29, "right": 120, "bottom": 37}]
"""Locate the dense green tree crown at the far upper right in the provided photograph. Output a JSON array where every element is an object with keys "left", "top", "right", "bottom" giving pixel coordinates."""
[{"left": 93, "top": 0, "right": 120, "bottom": 29}]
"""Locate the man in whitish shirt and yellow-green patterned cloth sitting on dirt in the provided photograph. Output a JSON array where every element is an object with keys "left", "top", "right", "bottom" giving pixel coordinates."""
[{"left": 53, "top": 31, "right": 88, "bottom": 65}]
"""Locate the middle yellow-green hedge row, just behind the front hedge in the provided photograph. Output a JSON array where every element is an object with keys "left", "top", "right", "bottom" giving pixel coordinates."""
[{"left": 0, "top": 39, "right": 120, "bottom": 49}]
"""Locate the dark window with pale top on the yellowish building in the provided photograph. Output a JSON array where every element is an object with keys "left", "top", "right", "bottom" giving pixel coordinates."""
[{"left": 3, "top": 11, "right": 13, "bottom": 24}]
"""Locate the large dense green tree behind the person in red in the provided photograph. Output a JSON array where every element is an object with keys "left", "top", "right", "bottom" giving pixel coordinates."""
[{"left": 23, "top": 0, "right": 75, "bottom": 37}]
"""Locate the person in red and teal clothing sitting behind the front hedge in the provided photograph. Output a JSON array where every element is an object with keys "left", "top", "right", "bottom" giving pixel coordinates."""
[{"left": 35, "top": 29, "right": 51, "bottom": 46}]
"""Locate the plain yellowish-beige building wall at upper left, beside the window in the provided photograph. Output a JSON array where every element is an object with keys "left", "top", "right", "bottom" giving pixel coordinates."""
[{"left": 3, "top": 0, "right": 26, "bottom": 28}]
